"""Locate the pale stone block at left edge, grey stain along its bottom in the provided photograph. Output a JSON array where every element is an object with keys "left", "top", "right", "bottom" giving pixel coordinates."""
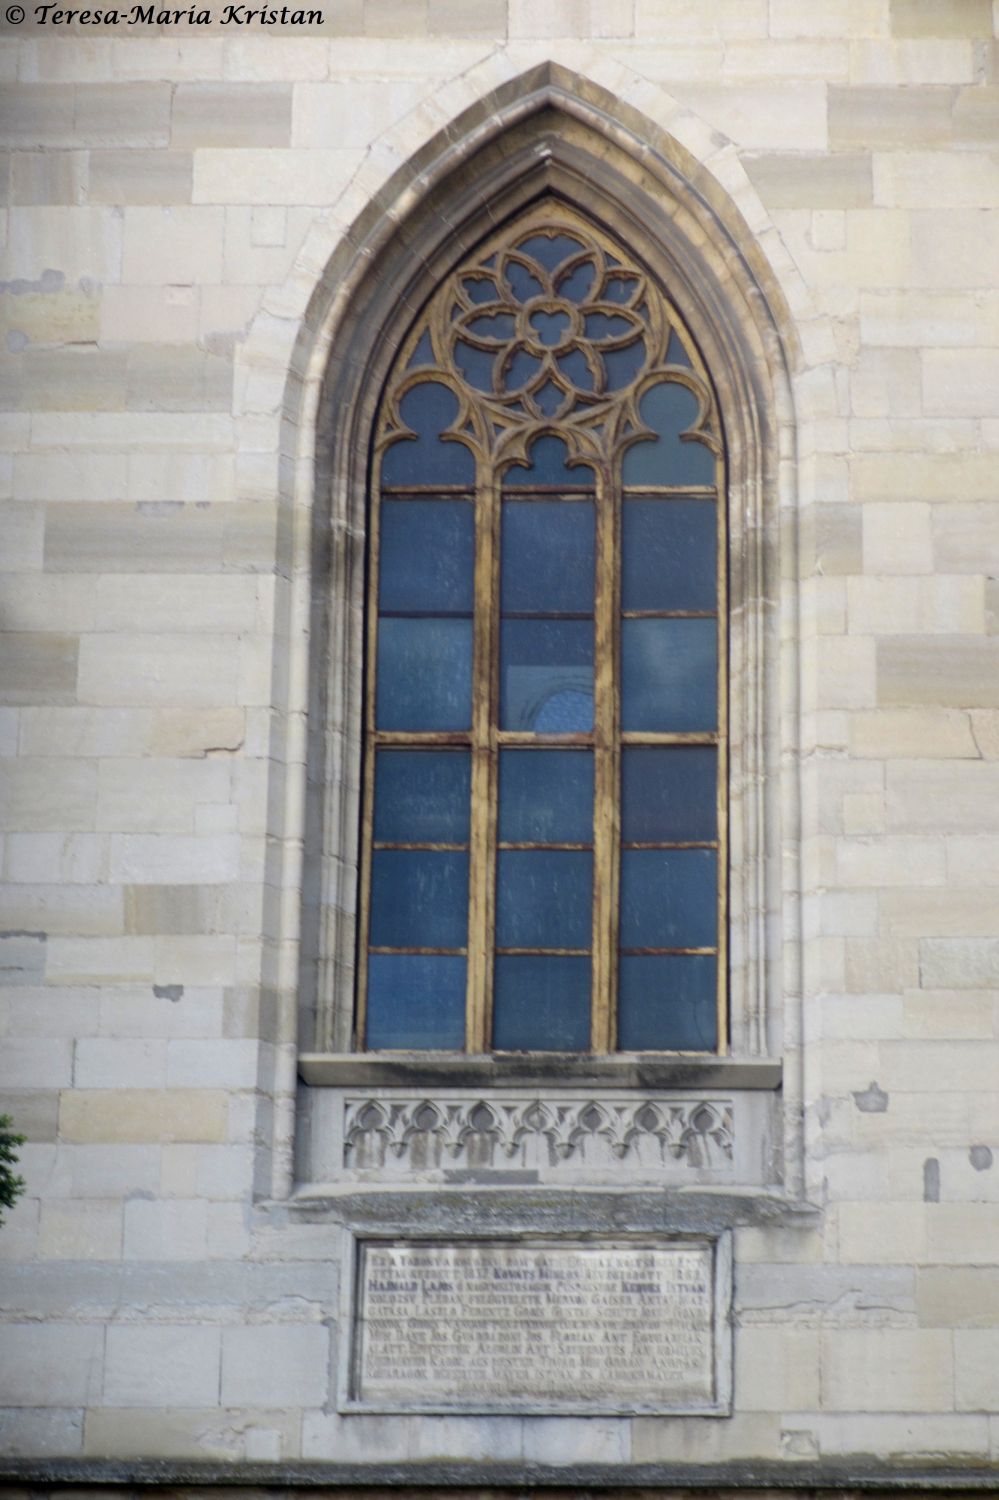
[{"left": 0, "top": 206, "right": 122, "bottom": 290}]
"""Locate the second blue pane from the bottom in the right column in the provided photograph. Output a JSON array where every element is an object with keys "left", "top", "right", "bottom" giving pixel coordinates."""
[{"left": 621, "top": 849, "right": 719, "bottom": 948}]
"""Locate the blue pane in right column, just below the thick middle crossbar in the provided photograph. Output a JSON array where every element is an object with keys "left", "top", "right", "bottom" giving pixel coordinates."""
[{"left": 621, "top": 746, "right": 717, "bottom": 843}]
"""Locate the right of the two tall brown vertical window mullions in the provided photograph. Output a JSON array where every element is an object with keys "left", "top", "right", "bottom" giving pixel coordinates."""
[{"left": 591, "top": 465, "right": 621, "bottom": 1053}]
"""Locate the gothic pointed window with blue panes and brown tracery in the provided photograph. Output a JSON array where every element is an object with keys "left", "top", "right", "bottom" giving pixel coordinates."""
[{"left": 354, "top": 200, "right": 728, "bottom": 1053}]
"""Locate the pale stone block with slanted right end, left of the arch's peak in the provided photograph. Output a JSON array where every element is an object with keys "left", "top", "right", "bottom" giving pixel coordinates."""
[{"left": 192, "top": 149, "right": 365, "bottom": 205}]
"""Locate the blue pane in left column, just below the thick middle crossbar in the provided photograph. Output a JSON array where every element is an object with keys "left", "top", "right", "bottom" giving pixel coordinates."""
[{"left": 375, "top": 750, "right": 471, "bottom": 843}]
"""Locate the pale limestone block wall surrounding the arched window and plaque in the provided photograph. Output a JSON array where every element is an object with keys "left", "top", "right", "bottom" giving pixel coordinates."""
[{"left": 0, "top": 0, "right": 999, "bottom": 1464}]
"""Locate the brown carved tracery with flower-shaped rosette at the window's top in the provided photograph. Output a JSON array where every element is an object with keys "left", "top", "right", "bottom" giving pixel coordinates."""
[{"left": 378, "top": 206, "right": 720, "bottom": 465}]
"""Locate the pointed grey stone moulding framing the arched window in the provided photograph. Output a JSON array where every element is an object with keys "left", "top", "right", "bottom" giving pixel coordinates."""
[{"left": 245, "top": 63, "right": 825, "bottom": 1197}]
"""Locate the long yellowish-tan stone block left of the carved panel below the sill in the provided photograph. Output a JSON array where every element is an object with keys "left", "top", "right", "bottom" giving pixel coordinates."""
[{"left": 59, "top": 1089, "right": 227, "bottom": 1145}]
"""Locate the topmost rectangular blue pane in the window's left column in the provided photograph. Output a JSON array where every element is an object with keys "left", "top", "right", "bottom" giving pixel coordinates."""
[{"left": 378, "top": 500, "right": 476, "bottom": 615}]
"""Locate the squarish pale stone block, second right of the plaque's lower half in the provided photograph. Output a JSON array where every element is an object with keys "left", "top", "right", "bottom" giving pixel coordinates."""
[{"left": 822, "top": 1328, "right": 954, "bottom": 1412}]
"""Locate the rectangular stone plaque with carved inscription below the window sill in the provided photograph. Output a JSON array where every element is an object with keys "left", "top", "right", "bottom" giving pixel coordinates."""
[{"left": 341, "top": 1238, "right": 731, "bottom": 1415}]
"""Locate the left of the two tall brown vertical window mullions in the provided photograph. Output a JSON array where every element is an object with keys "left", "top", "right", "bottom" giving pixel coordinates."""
[{"left": 465, "top": 459, "right": 500, "bottom": 1053}]
